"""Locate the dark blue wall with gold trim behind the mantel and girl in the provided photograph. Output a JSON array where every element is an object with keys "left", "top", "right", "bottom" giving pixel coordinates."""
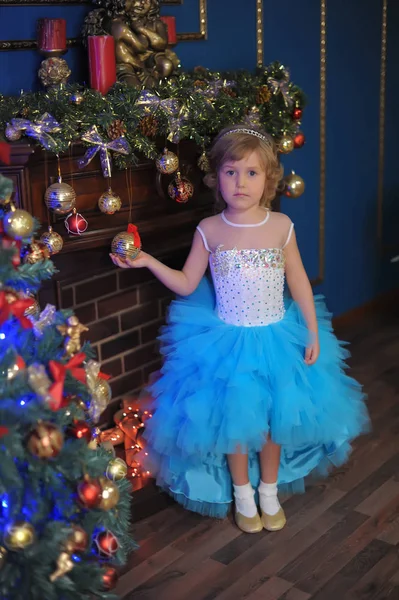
[{"left": 0, "top": 0, "right": 399, "bottom": 314}]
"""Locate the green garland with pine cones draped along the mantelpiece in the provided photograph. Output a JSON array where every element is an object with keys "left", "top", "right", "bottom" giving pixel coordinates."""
[{"left": 0, "top": 62, "right": 305, "bottom": 168}]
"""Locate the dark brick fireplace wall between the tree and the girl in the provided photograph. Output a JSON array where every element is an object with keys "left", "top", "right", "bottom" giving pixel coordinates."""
[{"left": 58, "top": 252, "right": 185, "bottom": 421}]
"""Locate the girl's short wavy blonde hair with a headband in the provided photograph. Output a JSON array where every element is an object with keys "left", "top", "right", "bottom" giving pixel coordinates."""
[{"left": 204, "top": 124, "right": 283, "bottom": 209}]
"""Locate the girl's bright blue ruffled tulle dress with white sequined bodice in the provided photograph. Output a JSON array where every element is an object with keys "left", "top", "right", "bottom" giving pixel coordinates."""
[{"left": 143, "top": 218, "right": 369, "bottom": 518}]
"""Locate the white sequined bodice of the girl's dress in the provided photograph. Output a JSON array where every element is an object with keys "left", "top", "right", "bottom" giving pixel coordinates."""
[{"left": 209, "top": 246, "right": 285, "bottom": 327}]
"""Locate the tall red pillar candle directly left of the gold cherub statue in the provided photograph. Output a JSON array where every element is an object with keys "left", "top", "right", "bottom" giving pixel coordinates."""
[{"left": 87, "top": 35, "right": 116, "bottom": 94}]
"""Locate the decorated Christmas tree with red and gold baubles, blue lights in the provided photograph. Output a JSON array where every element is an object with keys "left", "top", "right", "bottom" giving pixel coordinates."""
[{"left": 0, "top": 175, "right": 134, "bottom": 600}]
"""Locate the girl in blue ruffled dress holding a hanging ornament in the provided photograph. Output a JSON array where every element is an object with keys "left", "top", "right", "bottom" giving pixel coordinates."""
[{"left": 111, "top": 125, "right": 368, "bottom": 533}]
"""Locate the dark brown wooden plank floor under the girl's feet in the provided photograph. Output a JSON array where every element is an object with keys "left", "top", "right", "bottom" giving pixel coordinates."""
[{"left": 116, "top": 313, "right": 399, "bottom": 600}]
